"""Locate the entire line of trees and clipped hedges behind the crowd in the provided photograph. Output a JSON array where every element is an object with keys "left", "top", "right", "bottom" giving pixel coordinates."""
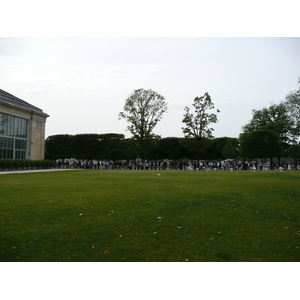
[{"left": 45, "top": 79, "right": 300, "bottom": 162}]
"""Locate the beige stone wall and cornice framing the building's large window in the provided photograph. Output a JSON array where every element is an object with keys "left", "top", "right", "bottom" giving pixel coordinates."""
[{"left": 0, "top": 102, "right": 48, "bottom": 160}]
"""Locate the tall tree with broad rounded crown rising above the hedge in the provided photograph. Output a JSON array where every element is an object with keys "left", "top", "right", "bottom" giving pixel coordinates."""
[{"left": 119, "top": 89, "right": 168, "bottom": 140}]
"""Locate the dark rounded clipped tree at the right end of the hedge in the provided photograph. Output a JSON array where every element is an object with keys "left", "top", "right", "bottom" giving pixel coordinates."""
[{"left": 240, "top": 130, "right": 283, "bottom": 159}]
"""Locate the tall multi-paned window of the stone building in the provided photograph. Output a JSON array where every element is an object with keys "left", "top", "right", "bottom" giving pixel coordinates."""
[{"left": 0, "top": 113, "right": 29, "bottom": 159}]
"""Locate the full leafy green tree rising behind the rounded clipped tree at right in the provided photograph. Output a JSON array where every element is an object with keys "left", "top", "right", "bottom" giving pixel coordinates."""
[{"left": 242, "top": 102, "right": 296, "bottom": 153}]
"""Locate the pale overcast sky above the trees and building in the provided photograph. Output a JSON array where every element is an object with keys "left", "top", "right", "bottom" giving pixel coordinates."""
[{"left": 0, "top": 37, "right": 300, "bottom": 137}]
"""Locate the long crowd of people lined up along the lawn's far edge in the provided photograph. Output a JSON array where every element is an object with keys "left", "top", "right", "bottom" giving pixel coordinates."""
[{"left": 56, "top": 158, "right": 299, "bottom": 171}]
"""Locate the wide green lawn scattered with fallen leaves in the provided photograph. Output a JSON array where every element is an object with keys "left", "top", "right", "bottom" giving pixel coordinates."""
[{"left": 0, "top": 170, "right": 300, "bottom": 262}]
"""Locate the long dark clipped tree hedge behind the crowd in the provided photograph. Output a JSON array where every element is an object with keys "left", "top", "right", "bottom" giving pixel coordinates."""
[{"left": 45, "top": 133, "right": 238, "bottom": 161}]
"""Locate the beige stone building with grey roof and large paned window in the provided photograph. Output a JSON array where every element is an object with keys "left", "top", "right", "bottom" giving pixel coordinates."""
[{"left": 0, "top": 89, "right": 49, "bottom": 160}]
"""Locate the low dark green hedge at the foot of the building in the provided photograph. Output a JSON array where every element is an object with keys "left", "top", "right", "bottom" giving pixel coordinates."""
[{"left": 0, "top": 159, "right": 56, "bottom": 171}]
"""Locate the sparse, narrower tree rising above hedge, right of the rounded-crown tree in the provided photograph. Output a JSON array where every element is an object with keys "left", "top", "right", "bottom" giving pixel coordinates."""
[{"left": 182, "top": 93, "right": 220, "bottom": 140}]
